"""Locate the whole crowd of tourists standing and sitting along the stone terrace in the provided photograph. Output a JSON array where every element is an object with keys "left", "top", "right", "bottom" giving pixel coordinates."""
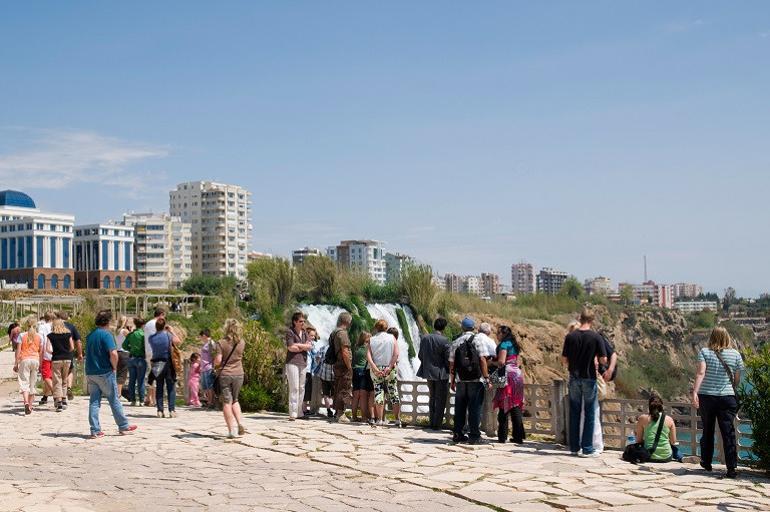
[{"left": 8, "top": 308, "right": 743, "bottom": 478}]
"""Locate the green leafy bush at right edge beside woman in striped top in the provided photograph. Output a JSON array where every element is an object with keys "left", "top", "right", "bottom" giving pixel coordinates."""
[{"left": 739, "top": 345, "right": 770, "bottom": 473}]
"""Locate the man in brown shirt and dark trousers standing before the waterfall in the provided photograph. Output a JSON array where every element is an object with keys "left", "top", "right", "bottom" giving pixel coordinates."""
[{"left": 324, "top": 311, "right": 353, "bottom": 423}]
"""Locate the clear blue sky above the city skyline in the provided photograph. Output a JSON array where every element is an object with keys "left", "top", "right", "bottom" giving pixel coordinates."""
[{"left": 0, "top": 1, "right": 770, "bottom": 295}]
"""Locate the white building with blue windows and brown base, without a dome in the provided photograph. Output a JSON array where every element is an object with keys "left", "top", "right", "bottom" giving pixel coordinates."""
[{"left": 74, "top": 223, "right": 136, "bottom": 289}]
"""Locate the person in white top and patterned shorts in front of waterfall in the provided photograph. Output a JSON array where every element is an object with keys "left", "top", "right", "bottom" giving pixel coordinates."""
[{"left": 366, "top": 320, "right": 401, "bottom": 427}]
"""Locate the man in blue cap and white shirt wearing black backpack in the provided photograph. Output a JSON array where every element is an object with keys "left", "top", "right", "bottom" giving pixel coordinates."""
[{"left": 449, "top": 317, "right": 492, "bottom": 444}]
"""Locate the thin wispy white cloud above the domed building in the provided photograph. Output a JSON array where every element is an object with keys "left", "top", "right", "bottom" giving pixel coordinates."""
[{"left": 0, "top": 130, "right": 169, "bottom": 189}]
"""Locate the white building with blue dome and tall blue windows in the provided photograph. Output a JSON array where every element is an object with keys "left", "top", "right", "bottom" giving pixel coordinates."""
[{"left": 0, "top": 190, "right": 75, "bottom": 290}]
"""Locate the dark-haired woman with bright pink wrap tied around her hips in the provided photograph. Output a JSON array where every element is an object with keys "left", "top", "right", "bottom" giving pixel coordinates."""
[{"left": 492, "top": 325, "right": 526, "bottom": 444}]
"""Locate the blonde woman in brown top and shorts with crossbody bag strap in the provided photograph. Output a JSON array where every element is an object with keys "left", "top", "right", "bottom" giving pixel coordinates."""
[{"left": 214, "top": 318, "right": 246, "bottom": 439}]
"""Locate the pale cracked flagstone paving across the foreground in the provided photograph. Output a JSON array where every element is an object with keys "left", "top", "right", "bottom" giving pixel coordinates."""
[{"left": 0, "top": 386, "right": 770, "bottom": 512}]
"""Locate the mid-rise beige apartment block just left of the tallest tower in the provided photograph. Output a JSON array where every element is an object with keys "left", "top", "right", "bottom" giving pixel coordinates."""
[{"left": 122, "top": 213, "right": 192, "bottom": 290}]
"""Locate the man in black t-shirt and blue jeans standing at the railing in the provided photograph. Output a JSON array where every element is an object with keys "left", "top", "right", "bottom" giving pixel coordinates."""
[{"left": 561, "top": 308, "right": 607, "bottom": 457}]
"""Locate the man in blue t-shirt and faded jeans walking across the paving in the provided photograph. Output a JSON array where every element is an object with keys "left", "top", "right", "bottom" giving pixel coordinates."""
[{"left": 86, "top": 310, "right": 136, "bottom": 439}]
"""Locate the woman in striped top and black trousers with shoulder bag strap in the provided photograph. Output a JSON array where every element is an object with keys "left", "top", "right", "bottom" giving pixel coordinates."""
[{"left": 692, "top": 327, "right": 744, "bottom": 478}]
